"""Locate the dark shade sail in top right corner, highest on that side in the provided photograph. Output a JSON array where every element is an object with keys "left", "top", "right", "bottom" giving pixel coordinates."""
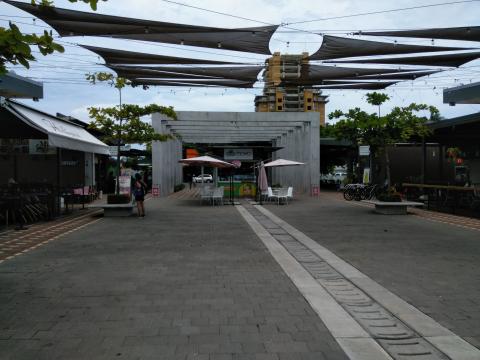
[{"left": 357, "top": 26, "right": 480, "bottom": 41}]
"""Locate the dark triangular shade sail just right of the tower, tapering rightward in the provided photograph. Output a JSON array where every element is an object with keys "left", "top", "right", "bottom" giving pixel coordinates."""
[{"left": 310, "top": 35, "right": 470, "bottom": 60}]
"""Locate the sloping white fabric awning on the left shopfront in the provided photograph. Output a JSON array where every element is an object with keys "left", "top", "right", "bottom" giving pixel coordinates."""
[{"left": 3, "top": 100, "right": 110, "bottom": 155}]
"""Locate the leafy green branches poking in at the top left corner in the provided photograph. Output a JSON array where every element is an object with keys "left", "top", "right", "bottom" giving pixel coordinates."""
[{"left": 0, "top": 0, "right": 107, "bottom": 75}]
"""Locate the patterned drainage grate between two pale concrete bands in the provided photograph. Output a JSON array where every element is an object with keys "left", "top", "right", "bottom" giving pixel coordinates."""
[{"left": 245, "top": 206, "right": 449, "bottom": 360}]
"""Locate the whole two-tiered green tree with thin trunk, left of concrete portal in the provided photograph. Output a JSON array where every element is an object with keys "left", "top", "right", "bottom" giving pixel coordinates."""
[{"left": 86, "top": 72, "right": 177, "bottom": 195}]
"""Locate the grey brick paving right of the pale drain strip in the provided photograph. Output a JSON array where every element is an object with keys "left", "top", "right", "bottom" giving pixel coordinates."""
[{"left": 266, "top": 193, "right": 480, "bottom": 348}]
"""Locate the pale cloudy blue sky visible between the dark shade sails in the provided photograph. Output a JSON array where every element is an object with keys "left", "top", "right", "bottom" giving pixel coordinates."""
[{"left": 0, "top": 0, "right": 480, "bottom": 122}]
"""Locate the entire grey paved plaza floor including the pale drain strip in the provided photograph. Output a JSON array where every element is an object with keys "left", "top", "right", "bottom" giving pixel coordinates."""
[{"left": 0, "top": 192, "right": 480, "bottom": 360}]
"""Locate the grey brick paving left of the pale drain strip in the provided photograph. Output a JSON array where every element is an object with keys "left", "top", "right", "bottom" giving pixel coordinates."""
[{"left": 0, "top": 198, "right": 347, "bottom": 360}]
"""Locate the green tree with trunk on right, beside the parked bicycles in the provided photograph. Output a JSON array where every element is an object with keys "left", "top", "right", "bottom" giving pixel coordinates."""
[{"left": 329, "top": 94, "right": 438, "bottom": 187}]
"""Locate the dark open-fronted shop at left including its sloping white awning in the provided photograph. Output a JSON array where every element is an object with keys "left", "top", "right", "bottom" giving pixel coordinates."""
[{"left": 0, "top": 99, "right": 109, "bottom": 223}]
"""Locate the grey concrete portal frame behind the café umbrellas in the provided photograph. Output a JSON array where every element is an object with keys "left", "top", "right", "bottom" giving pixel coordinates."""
[{"left": 152, "top": 111, "right": 320, "bottom": 196}]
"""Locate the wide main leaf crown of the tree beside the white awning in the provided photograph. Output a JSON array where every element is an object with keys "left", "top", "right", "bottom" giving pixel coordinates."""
[{"left": 88, "top": 104, "right": 176, "bottom": 144}]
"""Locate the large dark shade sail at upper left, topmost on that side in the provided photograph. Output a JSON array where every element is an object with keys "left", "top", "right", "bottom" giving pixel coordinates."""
[{"left": 5, "top": 1, "right": 278, "bottom": 55}]
